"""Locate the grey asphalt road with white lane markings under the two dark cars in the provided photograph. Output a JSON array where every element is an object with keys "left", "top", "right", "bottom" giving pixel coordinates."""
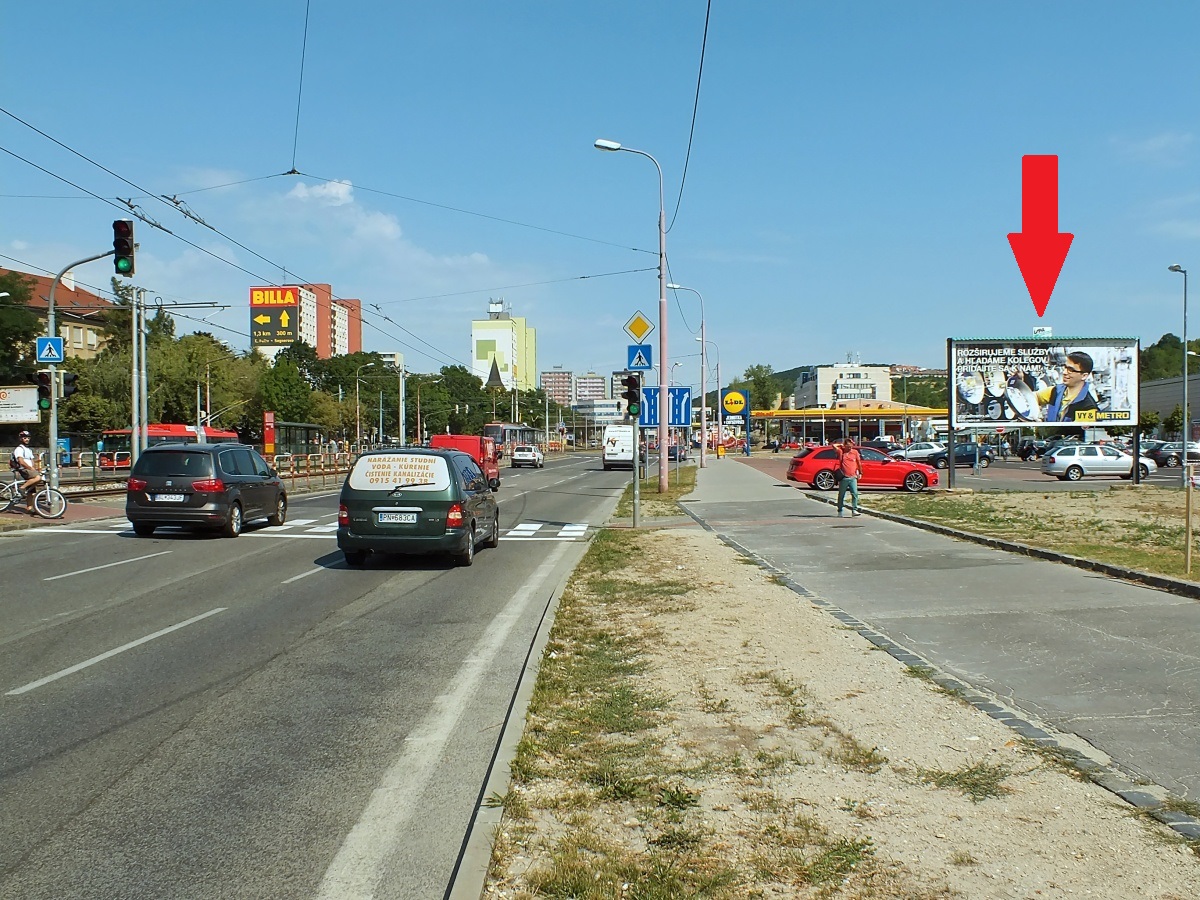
[{"left": 0, "top": 457, "right": 629, "bottom": 900}]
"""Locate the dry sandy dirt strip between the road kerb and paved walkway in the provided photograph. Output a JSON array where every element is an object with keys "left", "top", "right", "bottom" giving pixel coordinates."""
[{"left": 487, "top": 518, "right": 1200, "bottom": 900}]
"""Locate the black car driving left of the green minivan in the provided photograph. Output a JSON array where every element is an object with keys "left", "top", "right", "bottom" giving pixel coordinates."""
[{"left": 125, "top": 444, "right": 288, "bottom": 538}]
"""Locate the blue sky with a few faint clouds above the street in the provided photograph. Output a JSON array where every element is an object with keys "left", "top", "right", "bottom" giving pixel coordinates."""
[{"left": 7, "top": 0, "right": 1200, "bottom": 386}]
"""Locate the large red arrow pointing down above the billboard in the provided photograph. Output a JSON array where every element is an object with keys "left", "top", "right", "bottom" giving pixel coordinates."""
[{"left": 1008, "top": 156, "right": 1075, "bottom": 317}]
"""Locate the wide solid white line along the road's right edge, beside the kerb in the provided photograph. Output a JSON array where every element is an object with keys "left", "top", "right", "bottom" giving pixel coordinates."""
[{"left": 317, "top": 545, "right": 566, "bottom": 900}]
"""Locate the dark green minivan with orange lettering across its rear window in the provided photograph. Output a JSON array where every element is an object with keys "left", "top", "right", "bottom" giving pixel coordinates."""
[{"left": 337, "top": 446, "right": 500, "bottom": 566}]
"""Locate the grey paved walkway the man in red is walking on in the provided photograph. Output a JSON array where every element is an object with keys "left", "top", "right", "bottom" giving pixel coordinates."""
[{"left": 683, "top": 455, "right": 1200, "bottom": 838}]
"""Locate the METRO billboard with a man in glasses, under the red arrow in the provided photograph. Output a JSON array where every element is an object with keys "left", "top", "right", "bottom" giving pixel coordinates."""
[{"left": 947, "top": 337, "right": 1140, "bottom": 431}]
